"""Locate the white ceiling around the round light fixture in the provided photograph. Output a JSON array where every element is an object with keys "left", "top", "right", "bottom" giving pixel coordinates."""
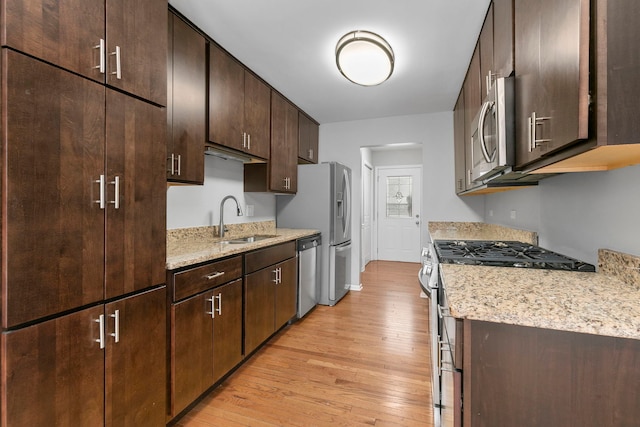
[{"left": 169, "top": 0, "right": 489, "bottom": 124}]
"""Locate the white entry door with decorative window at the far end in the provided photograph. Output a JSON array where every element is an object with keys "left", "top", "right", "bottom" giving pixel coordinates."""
[{"left": 376, "top": 166, "right": 422, "bottom": 262}]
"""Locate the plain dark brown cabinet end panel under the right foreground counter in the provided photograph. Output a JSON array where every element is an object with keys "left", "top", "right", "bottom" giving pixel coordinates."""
[{"left": 463, "top": 320, "right": 640, "bottom": 427}]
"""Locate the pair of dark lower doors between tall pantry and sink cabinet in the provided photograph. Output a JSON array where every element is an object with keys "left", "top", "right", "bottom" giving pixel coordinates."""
[{"left": 171, "top": 279, "right": 242, "bottom": 416}]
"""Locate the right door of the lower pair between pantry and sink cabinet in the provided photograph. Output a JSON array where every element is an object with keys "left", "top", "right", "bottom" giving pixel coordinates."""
[{"left": 213, "top": 279, "right": 242, "bottom": 381}]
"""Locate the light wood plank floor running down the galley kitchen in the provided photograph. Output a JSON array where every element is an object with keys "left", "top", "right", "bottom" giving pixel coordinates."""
[{"left": 177, "top": 261, "right": 432, "bottom": 427}]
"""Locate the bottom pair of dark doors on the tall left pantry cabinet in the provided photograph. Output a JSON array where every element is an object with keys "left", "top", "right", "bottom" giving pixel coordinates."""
[{"left": 1, "top": 287, "right": 166, "bottom": 426}]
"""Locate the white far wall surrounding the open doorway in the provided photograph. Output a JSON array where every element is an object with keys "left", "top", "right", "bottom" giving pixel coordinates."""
[{"left": 318, "top": 112, "right": 484, "bottom": 290}]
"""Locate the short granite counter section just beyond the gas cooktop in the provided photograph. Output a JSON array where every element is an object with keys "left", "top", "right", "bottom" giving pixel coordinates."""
[{"left": 429, "top": 221, "right": 538, "bottom": 245}]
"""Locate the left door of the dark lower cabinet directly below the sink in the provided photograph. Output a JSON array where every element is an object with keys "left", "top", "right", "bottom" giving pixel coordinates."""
[{"left": 244, "top": 267, "right": 275, "bottom": 355}]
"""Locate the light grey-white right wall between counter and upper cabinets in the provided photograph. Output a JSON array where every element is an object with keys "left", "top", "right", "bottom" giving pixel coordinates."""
[{"left": 486, "top": 165, "right": 640, "bottom": 264}]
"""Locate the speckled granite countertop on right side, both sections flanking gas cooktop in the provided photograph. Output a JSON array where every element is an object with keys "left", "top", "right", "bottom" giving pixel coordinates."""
[{"left": 429, "top": 222, "right": 640, "bottom": 339}]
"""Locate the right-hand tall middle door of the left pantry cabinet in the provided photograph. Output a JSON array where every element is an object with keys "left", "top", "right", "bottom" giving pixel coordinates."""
[{"left": 105, "top": 90, "right": 166, "bottom": 298}]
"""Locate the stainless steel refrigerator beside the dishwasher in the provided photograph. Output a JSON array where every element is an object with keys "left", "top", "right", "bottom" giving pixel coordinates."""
[{"left": 276, "top": 162, "right": 351, "bottom": 306}]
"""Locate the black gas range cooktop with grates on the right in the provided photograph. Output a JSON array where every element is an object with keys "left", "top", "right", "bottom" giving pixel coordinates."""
[{"left": 434, "top": 240, "right": 596, "bottom": 272}]
